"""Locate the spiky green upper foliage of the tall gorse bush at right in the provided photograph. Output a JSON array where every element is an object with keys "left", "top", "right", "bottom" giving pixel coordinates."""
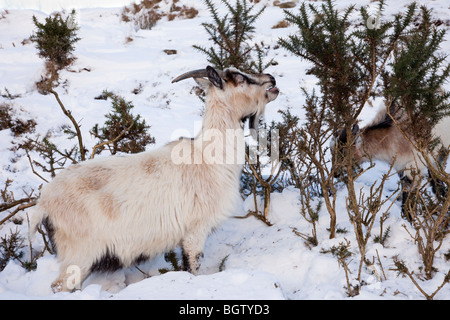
[{"left": 279, "top": 1, "right": 450, "bottom": 138}]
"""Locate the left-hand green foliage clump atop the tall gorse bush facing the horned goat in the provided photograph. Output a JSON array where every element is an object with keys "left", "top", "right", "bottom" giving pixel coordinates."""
[{"left": 279, "top": 1, "right": 363, "bottom": 125}]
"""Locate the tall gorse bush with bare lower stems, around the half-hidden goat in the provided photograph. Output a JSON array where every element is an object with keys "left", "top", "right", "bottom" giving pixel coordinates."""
[{"left": 279, "top": 0, "right": 450, "bottom": 295}]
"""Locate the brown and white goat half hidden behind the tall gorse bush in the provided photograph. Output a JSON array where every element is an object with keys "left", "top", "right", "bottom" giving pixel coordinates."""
[{"left": 330, "top": 110, "right": 450, "bottom": 215}]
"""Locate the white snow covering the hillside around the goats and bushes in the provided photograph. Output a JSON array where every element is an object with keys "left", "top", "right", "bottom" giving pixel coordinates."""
[{"left": 0, "top": 0, "right": 450, "bottom": 299}]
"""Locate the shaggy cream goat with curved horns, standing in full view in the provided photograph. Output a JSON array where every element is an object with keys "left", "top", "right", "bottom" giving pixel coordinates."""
[{"left": 30, "top": 66, "right": 279, "bottom": 291}]
